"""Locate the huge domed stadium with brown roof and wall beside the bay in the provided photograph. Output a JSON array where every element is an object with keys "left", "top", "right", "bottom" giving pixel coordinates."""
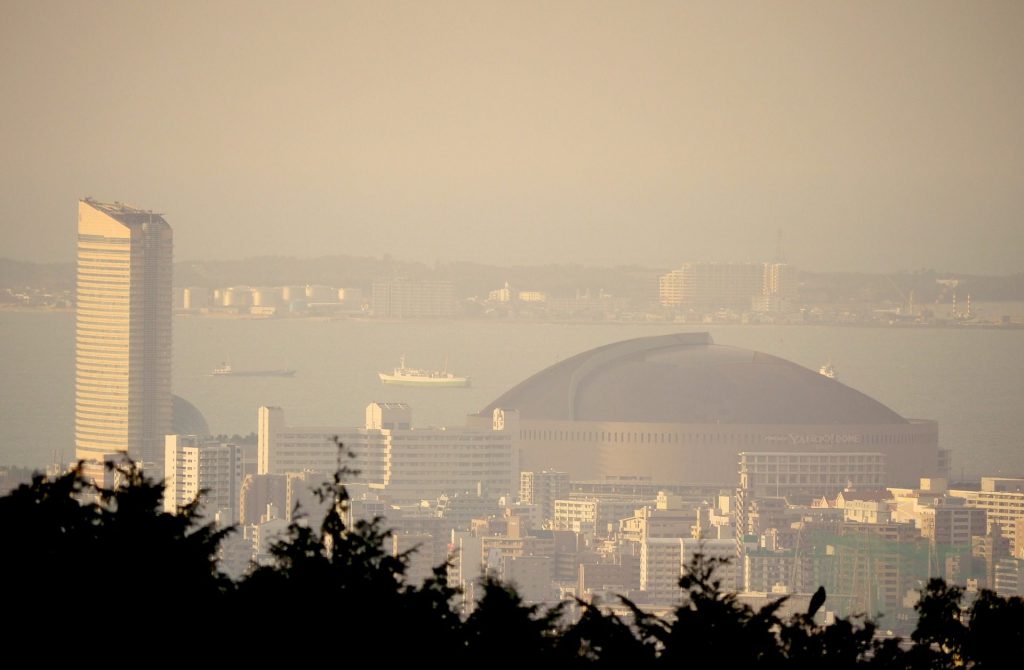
[{"left": 480, "top": 333, "right": 948, "bottom": 486}]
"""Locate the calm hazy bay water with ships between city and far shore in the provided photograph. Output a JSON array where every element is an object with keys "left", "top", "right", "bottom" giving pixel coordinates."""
[{"left": 0, "top": 311, "right": 1024, "bottom": 475}]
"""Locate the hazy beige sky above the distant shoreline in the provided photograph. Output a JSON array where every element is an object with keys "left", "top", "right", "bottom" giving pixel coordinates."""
[{"left": 0, "top": 0, "right": 1024, "bottom": 274}]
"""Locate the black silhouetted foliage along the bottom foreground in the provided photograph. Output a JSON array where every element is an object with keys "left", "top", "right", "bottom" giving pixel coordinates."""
[{"left": 0, "top": 468, "right": 1024, "bottom": 670}]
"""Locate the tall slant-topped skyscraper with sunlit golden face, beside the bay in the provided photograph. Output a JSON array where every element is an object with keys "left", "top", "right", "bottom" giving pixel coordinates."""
[{"left": 75, "top": 198, "right": 173, "bottom": 478}]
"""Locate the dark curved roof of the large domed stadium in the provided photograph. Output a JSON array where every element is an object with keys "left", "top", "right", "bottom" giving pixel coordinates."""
[{"left": 482, "top": 333, "right": 907, "bottom": 425}]
